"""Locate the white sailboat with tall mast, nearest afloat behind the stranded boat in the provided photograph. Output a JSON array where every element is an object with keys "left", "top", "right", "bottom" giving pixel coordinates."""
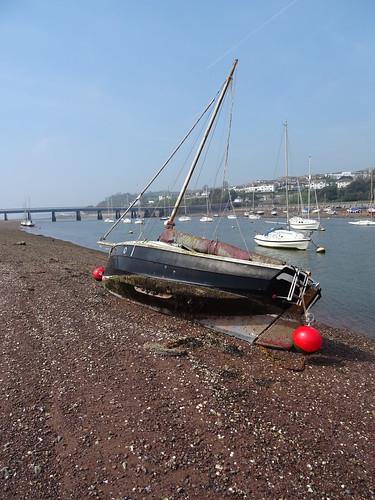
[{"left": 254, "top": 120, "right": 311, "bottom": 250}]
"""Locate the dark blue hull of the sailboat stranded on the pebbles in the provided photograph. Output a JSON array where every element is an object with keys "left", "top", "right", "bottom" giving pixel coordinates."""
[{"left": 103, "top": 243, "right": 324, "bottom": 317}]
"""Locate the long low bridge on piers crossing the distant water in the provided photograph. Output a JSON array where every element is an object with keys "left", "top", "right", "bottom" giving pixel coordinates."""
[{"left": 0, "top": 207, "right": 163, "bottom": 222}]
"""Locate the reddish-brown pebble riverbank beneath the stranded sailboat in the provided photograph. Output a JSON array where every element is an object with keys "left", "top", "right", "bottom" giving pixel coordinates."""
[{"left": 0, "top": 222, "right": 375, "bottom": 499}]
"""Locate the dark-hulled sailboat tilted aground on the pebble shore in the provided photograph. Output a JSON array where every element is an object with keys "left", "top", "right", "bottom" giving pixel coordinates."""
[{"left": 98, "top": 60, "right": 321, "bottom": 344}]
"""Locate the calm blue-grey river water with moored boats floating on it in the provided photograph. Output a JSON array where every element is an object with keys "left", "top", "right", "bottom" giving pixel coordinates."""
[{"left": 27, "top": 217, "right": 375, "bottom": 338}]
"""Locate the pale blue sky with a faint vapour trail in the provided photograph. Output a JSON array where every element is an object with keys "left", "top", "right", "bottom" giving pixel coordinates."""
[{"left": 0, "top": 0, "right": 375, "bottom": 208}]
